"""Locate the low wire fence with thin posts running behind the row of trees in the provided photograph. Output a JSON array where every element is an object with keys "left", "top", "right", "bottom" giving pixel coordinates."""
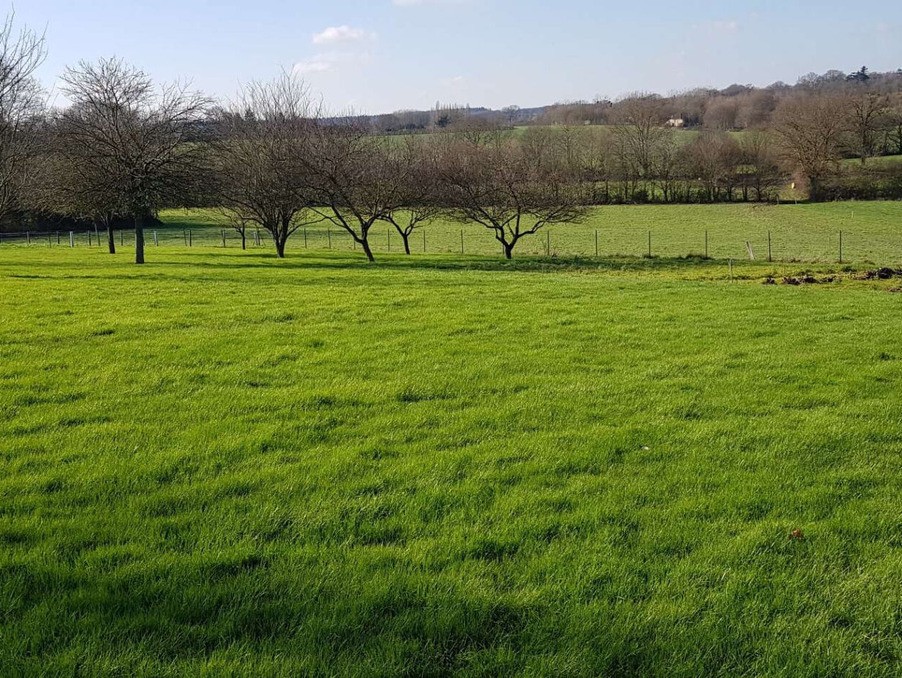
[{"left": 0, "top": 225, "right": 902, "bottom": 264}]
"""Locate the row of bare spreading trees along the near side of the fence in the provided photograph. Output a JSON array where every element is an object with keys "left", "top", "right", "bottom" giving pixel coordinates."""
[{"left": 25, "top": 59, "right": 590, "bottom": 263}]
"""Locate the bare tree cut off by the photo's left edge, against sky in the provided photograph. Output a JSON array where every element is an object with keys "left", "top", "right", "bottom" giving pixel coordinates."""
[{"left": 0, "top": 13, "right": 46, "bottom": 221}]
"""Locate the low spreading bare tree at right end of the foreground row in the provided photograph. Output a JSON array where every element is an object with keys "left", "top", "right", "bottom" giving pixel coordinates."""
[{"left": 440, "top": 133, "right": 587, "bottom": 259}]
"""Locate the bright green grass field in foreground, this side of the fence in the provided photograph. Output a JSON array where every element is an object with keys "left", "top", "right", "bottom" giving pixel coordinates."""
[{"left": 0, "top": 247, "right": 902, "bottom": 678}]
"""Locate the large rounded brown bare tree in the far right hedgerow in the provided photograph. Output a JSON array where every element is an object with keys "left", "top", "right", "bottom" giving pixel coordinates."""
[{"left": 774, "top": 94, "right": 847, "bottom": 200}]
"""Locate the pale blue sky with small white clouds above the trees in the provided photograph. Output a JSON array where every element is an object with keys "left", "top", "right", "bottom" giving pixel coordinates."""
[{"left": 12, "top": 0, "right": 902, "bottom": 113}]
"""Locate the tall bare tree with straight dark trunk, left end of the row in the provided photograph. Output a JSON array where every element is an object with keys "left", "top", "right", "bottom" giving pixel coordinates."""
[{"left": 61, "top": 59, "right": 210, "bottom": 264}]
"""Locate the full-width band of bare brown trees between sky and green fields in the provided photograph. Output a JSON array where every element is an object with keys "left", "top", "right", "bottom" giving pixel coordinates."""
[{"left": 0, "top": 11, "right": 902, "bottom": 263}]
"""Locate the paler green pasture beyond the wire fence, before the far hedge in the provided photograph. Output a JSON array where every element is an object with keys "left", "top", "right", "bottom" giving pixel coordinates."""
[{"left": 0, "top": 202, "right": 902, "bottom": 265}]
